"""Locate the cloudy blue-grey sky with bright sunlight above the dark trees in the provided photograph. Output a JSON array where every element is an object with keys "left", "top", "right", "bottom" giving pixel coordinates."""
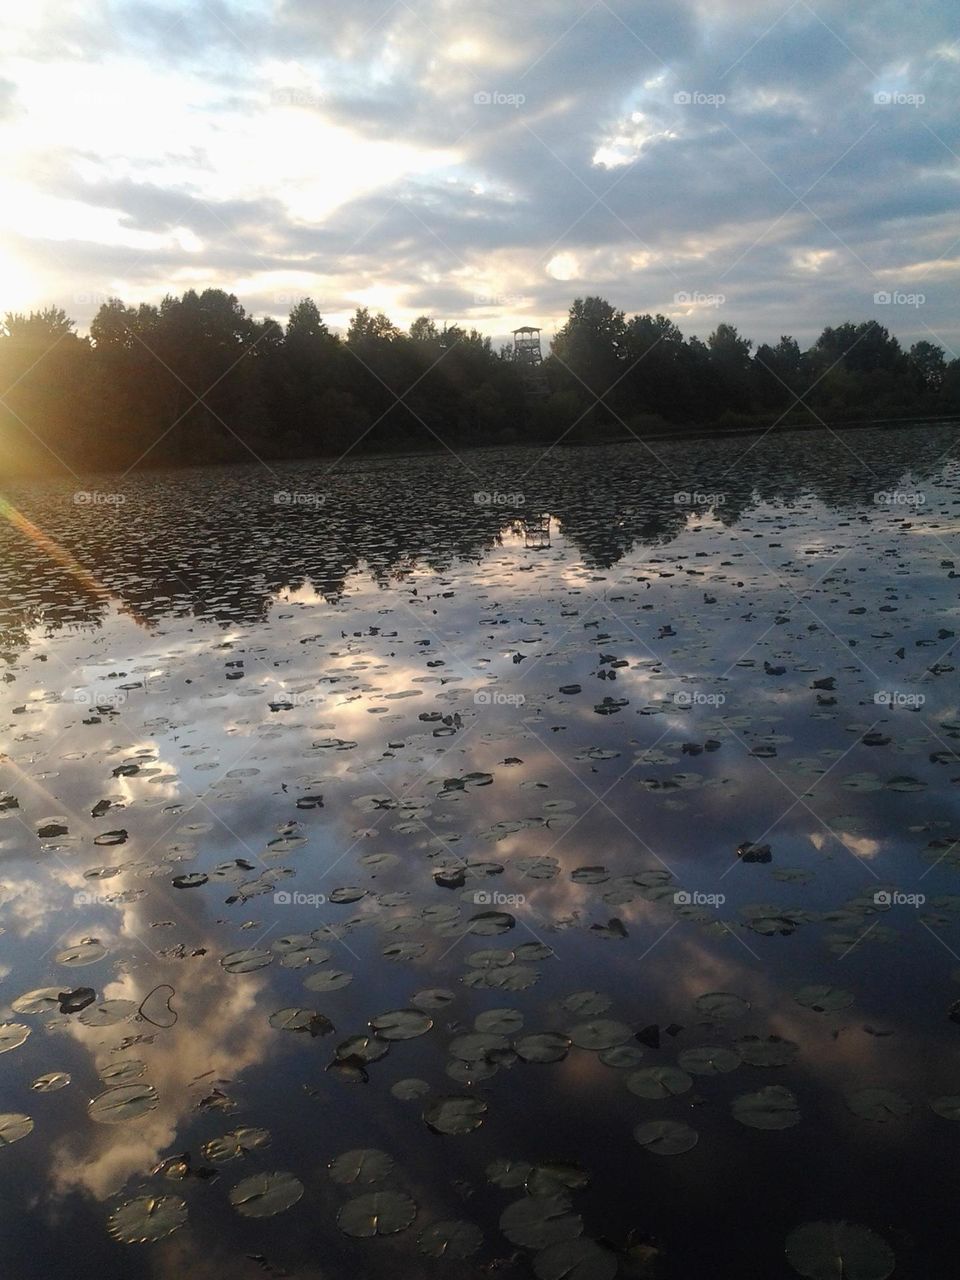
[{"left": 0, "top": 0, "right": 960, "bottom": 358}]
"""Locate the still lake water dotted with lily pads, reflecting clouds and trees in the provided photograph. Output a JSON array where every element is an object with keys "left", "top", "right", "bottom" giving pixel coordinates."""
[{"left": 0, "top": 428, "right": 960, "bottom": 1280}]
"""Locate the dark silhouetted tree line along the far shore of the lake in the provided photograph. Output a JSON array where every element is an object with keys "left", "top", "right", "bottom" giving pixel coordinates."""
[{"left": 0, "top": 289, "right": 960, "bottom": 470}]
